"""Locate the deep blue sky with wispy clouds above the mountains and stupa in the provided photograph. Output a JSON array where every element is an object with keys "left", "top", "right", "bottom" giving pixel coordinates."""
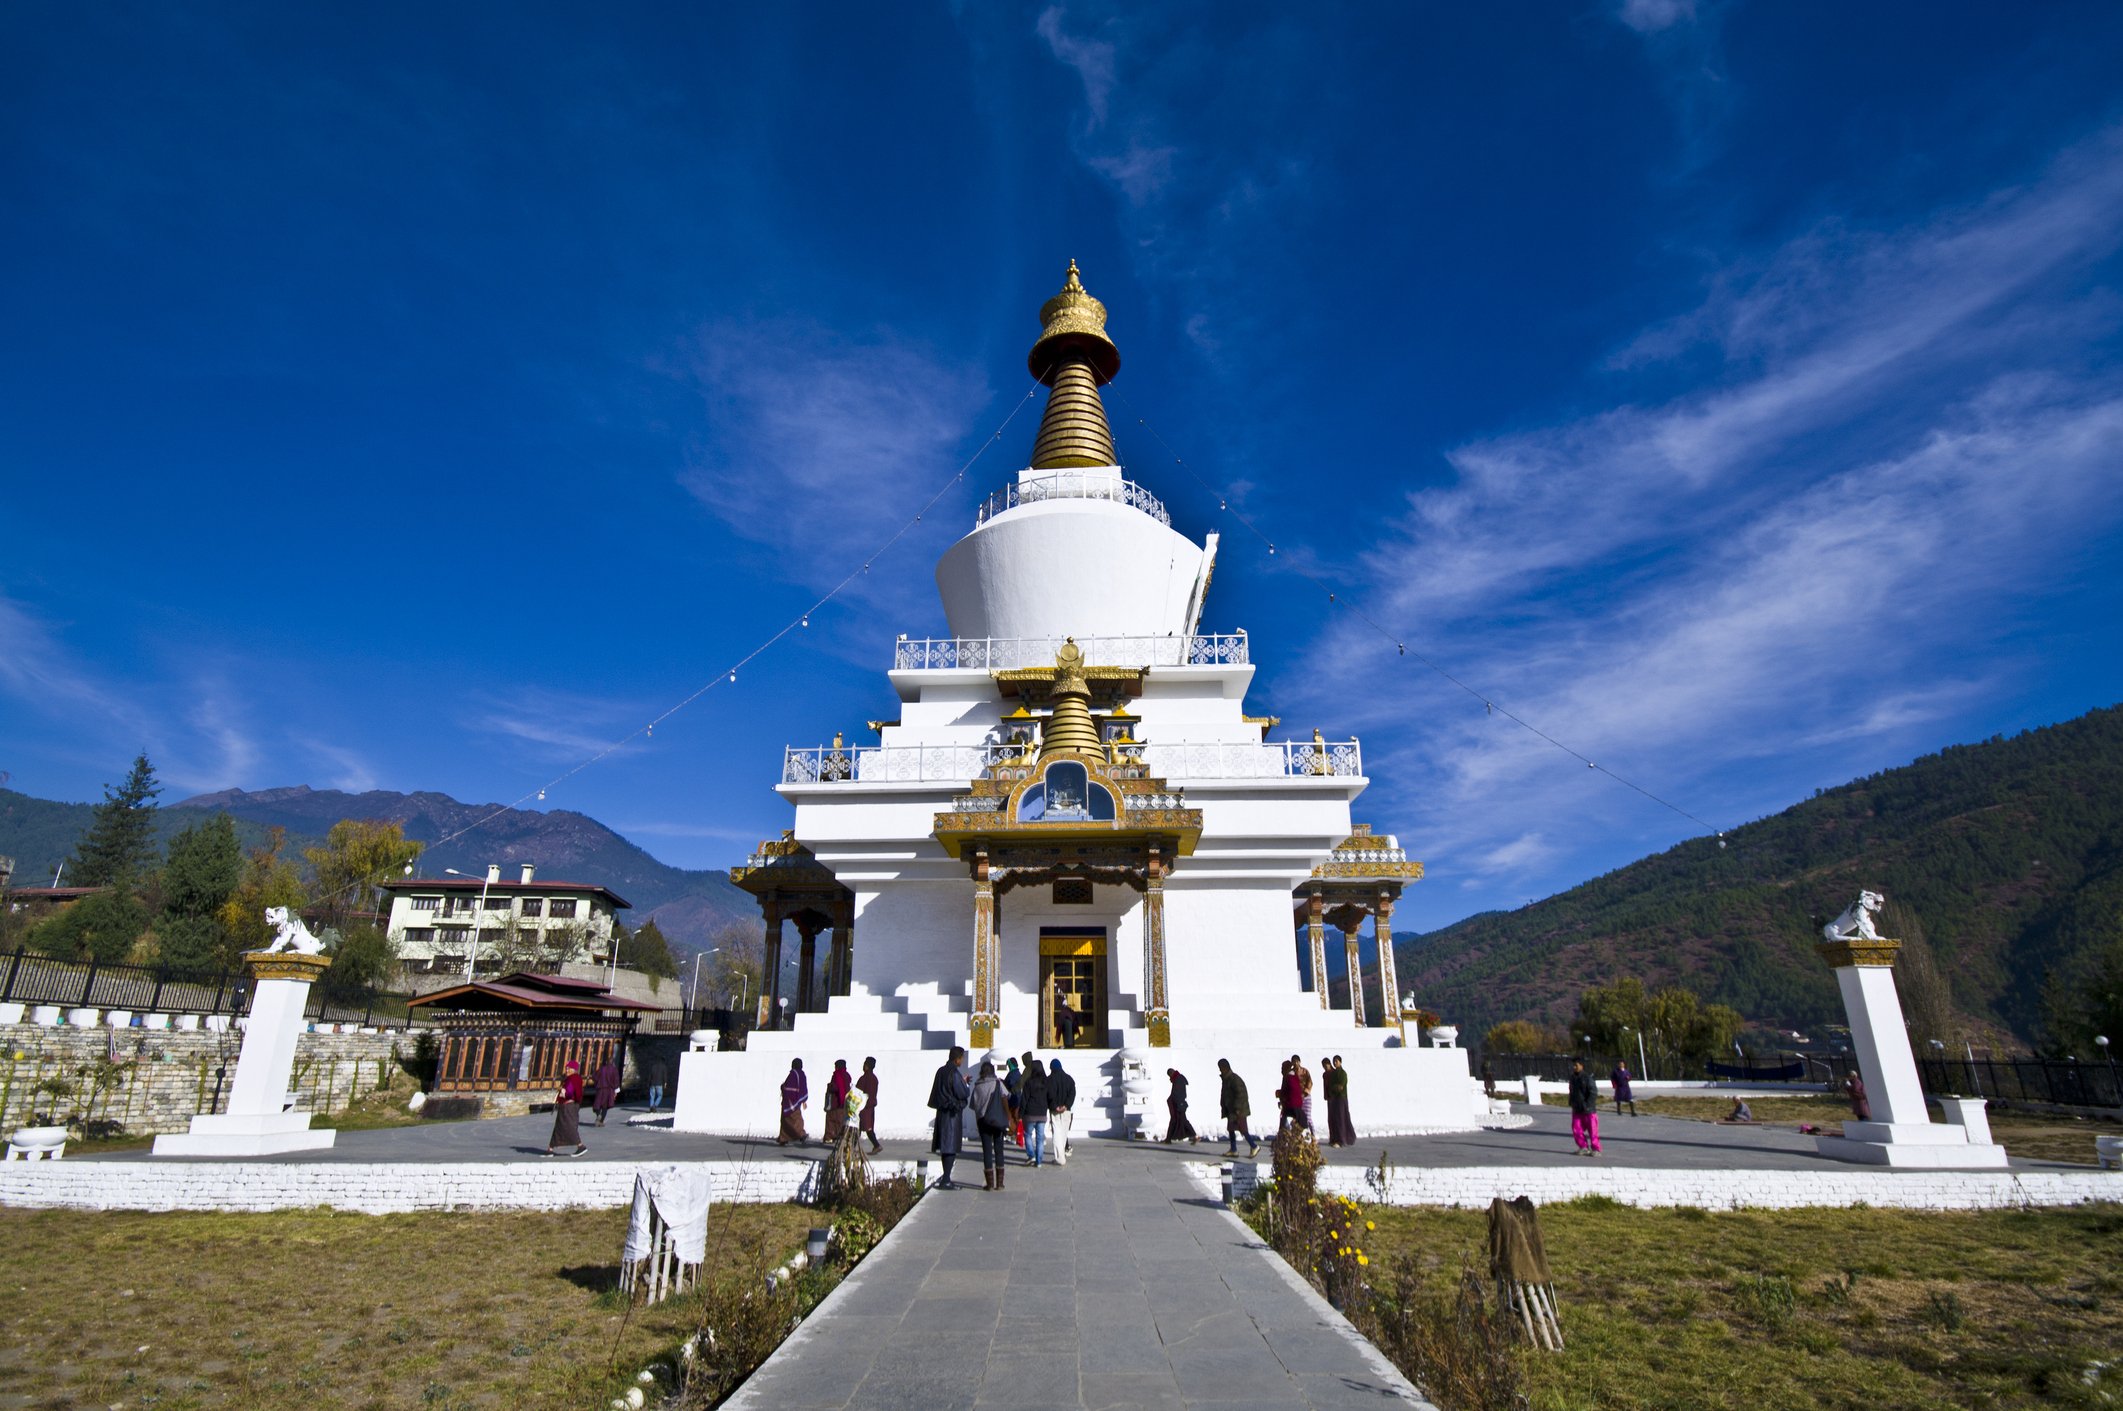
[{"left": 0, "top": 0, "right": 2123, "bottom": 929}]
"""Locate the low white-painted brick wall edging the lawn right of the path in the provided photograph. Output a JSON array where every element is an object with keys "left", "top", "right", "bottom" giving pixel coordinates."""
[{"left": 1195, "top": 1161, "right": 2123, "bottom": 1209}]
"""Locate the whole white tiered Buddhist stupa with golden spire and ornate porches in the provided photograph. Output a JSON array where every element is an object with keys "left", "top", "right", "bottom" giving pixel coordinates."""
[{"left": 677, "top": 263, "right": 1482, "bottom": 1135}]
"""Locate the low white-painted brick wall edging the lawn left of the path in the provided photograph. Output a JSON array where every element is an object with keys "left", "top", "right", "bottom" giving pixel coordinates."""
[{"left": 0, "top": 1159, "right": 915, "bottom": 1216}]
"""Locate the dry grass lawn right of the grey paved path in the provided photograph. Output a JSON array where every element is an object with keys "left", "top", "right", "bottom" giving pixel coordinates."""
[{"left": 1365, "top": 1199, "right": 2123, "bottom": 1411}]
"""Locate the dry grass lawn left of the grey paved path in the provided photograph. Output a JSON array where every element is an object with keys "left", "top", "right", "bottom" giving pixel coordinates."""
[{"left": 0, "top": 1205, "right": 817, "bottom": 1411}]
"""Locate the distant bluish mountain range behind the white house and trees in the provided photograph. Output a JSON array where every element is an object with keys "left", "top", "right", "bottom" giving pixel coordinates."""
[{"left": 0, "top": 785, "right": 760, "bottom": 953}]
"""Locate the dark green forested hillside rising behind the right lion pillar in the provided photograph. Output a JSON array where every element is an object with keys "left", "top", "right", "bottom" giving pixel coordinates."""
[{"left": 1395, "top": 707, "right": 2123, "bottom": 1042}]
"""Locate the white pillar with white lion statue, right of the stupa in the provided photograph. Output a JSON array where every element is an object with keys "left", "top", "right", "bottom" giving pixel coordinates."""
[{"left": 1815, "top": 891, "right": 2006, "bottom": 1167}]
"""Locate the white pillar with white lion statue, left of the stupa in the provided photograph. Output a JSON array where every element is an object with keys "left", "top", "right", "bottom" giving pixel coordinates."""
[{"left": 155, "top": 906, "right": 340, "bottom": 1156}]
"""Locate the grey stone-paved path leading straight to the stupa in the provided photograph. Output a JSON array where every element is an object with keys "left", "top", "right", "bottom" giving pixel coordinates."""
[{"left": 728, "top": 1144, "right": 1429, "bottom": 1411}]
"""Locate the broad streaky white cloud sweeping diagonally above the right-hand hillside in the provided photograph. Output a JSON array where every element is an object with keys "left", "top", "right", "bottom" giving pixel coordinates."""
[{"left": 1282, "top": 123, "right": 2123, "bottom": 891}]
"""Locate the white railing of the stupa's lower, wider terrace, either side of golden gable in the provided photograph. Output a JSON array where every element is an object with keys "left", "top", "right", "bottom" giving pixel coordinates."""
[{"left": 781, "top": 741, "right": 1363, "bottom": 785}]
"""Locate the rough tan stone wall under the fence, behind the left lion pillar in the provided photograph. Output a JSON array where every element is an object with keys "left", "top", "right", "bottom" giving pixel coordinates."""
[{"left": 0, "top": 1025, "right": 414, "bottom": 1133}]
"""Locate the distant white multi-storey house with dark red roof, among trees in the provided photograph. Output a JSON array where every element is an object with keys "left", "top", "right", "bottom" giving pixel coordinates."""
[{"left": 382, "top": 861, "right": 633, "bottom": 974}]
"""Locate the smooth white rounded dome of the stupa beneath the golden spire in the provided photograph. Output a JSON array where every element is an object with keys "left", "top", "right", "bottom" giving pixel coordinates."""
[{"left": 936, "top": 499, "right": 1202, "bottom": 637}]
